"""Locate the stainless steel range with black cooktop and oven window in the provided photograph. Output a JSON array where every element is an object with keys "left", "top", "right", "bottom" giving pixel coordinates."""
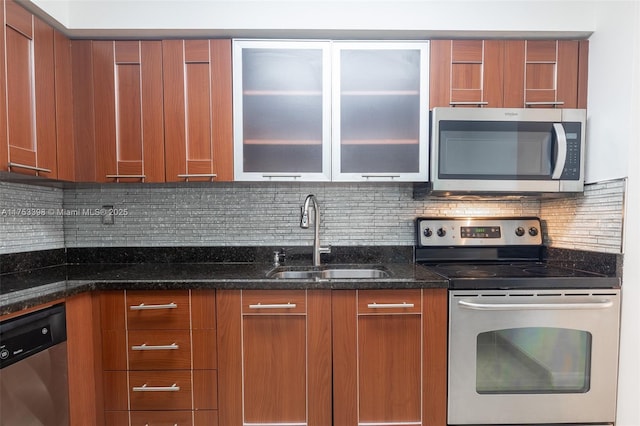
[{"left": 415, "top": 217, "right": 620, "bottom": 425}]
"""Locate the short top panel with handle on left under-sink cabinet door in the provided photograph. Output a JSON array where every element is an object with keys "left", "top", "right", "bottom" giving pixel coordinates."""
[{"left": 242, "top": 290, "right": 307, "bottom": 315}]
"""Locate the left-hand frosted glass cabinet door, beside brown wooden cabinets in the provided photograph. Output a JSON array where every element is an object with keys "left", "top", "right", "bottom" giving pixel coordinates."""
[{"left": 233, "top": 40, "right": 331, "bottom": 181}]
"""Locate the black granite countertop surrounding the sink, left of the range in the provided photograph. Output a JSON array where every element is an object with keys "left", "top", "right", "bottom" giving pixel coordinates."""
[{"left": 0, "top": 262, "right": 448, "bottom": 315}]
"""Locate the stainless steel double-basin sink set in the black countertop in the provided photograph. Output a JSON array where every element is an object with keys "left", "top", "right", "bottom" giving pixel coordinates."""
[{"left": 267, "top": 266, "right": 389, "bottom": 280}]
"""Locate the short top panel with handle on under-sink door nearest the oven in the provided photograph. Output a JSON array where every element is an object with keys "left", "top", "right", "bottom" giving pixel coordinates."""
[{"left": 358, "top": 289, "right": 422, "bottom": 315}]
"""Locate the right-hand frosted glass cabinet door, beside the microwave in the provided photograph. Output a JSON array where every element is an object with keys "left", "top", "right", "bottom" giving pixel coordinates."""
[{"left": 332, "top": 42, "right": 429, "bottom": 181}]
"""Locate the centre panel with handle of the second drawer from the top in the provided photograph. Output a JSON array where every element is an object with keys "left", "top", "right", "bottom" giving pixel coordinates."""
[{"left": 128, "top": 330, "right": 191, "bottom": 370}]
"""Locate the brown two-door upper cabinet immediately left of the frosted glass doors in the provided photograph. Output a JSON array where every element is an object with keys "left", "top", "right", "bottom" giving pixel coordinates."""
[{"left": 72, "top": 40, "right": 233, "bottom": 182}]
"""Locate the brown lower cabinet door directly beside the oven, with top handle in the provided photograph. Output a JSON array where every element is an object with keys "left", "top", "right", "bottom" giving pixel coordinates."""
[{"left": 332, "top": 289, "right": 447, "bottom": 426}]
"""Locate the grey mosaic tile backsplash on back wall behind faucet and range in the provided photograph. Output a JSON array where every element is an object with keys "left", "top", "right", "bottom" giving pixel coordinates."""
[{"left": 64, "top": 183, "right": 539, "bottom": 247}]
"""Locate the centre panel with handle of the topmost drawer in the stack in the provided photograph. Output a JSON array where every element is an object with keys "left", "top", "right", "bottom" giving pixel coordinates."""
[{"left": 126, "top": 291, "right": 190, "bottom": 330}]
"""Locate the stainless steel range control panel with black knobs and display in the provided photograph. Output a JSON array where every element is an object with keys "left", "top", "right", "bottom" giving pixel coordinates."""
[{"left": 416, "top": 217, "right": 542, "bottom": 247}]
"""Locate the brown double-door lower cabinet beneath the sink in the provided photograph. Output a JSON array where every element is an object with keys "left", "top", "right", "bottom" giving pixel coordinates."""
[{"left": 216, "top": 289, "right": 447, "bottom": 426}]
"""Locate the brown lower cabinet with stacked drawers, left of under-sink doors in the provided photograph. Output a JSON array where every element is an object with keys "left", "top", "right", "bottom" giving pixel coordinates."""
[{"left": 100, "top": 290, "right": 218, "bottom": 426}]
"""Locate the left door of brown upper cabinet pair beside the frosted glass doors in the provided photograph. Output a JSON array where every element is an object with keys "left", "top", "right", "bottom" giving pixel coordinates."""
[{"left": 92, "top": 41, "right": 164, "bottom": 182}]
